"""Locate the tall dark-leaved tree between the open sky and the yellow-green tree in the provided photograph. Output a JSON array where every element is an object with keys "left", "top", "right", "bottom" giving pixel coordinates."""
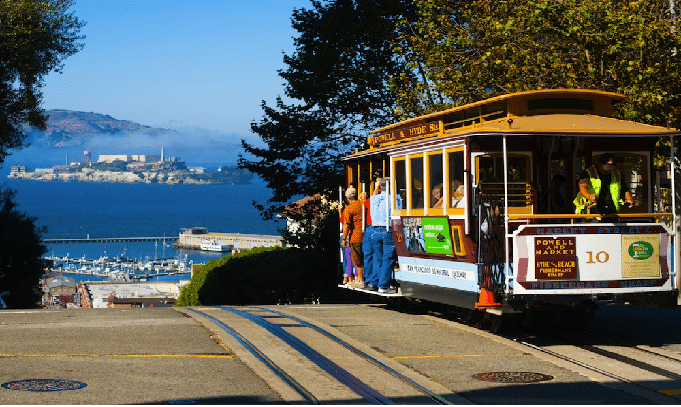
[{"left": 239, "top": 0, "right": 414, "bottom": 219}]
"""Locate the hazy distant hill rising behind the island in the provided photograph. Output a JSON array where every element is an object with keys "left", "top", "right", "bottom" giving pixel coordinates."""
[{"left": 24, "top": 109, "right": 176, "bottom": 147}]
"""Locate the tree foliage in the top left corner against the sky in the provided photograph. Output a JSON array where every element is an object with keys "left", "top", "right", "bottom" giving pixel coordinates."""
[{"left": 0, "top": 0, "right": 84, "bottom": 163}]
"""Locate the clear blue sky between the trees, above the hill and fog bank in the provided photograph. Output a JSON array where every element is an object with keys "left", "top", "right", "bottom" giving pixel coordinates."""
[{"left": 43, "top": 0, "right": 311, "bottom": 143}]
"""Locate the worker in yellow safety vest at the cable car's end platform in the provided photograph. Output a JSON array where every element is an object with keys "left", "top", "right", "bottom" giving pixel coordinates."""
[{"left": 572, "top": 153, "right": 634, "bottom": 215}]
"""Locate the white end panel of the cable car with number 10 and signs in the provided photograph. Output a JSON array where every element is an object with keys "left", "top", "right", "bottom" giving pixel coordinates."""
[{"left": 513, "top": 224, "right": 670, "bottom": 294}]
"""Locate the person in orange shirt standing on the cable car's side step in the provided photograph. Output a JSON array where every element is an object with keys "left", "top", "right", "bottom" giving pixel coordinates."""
[{"left": 343, "top": 187, "right": 364, "bottom": 288}]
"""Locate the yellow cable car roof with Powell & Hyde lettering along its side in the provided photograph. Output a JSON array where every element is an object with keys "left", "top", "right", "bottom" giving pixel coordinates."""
[{"left": 346, "top": 89, "right": 681, "bottom": 159}]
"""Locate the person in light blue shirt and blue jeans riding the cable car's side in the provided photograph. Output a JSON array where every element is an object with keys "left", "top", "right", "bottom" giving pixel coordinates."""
[{"left": 368, "top": 177, "right": 397, "bottom": 294}]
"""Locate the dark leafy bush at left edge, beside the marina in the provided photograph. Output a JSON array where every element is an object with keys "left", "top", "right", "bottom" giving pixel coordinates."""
[{"left": 0, "top": 189, "right": 47, "bottom": 308}]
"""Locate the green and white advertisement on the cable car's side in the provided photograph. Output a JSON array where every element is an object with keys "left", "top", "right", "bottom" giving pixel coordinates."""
[{"left": 402, "top": 217, "right": 454, "bottom": 255}]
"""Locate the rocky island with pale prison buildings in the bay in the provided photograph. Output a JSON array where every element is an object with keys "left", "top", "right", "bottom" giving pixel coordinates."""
[{"left": 7, "top": 149, "right": 253, "bottom": 184}]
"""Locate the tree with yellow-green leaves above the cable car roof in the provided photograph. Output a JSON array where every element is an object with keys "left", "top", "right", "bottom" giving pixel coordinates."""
[{"left": 393, "top": 0, "right": 681, "bottom": 125}]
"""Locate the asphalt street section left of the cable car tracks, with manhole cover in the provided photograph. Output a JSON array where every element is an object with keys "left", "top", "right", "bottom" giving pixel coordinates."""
[{"left": 0, "top": 308, "right": 282, "bottom": 405}]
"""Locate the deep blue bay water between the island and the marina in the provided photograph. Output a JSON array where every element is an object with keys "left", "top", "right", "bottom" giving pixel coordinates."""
[{"left": 0, "top": 179, "right": 284, "bottom": 280}]
